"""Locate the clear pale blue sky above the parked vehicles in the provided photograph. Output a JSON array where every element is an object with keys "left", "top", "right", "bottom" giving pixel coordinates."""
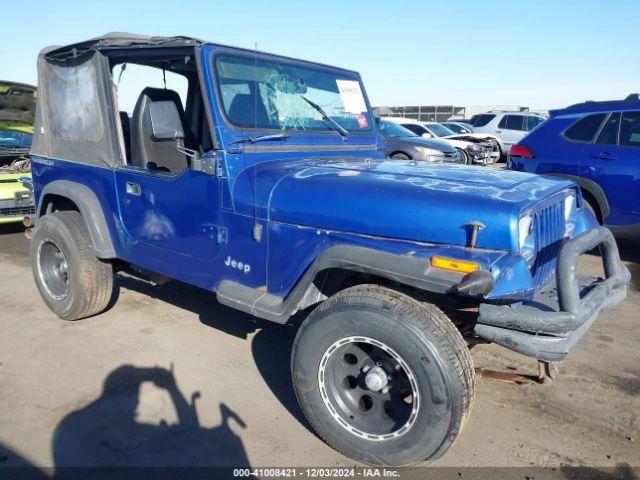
[{"left": 0, "top": 0, "right": 640, "bottom": 109}]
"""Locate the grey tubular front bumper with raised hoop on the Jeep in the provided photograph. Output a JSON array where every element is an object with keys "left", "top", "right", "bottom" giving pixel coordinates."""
[{"left": 474, "top": 227, "right": 631, "bottom": 362}]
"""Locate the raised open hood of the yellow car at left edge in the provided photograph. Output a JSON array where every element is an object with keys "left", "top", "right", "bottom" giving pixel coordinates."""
[{"left": 0, "top": 80, "right": 36, "bottom": 126}]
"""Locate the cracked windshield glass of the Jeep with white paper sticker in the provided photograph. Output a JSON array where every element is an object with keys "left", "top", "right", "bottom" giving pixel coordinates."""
[{"left": 215, "top": 55, "right": 371, "bottom": 134}]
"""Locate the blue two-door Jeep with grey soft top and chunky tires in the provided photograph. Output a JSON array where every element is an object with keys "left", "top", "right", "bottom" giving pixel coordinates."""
[{"left": 30, "top": 34, "right": 629, "bottom": 465}]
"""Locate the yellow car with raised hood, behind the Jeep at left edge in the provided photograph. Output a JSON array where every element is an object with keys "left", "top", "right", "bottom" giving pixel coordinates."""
[{"left": 0, "top": 81, "right": 36, "bottom": 224}]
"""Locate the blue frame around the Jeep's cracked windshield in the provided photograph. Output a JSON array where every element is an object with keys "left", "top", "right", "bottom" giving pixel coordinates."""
[{"left": 208, "top": 48, "right": 376, "bottom": 137}]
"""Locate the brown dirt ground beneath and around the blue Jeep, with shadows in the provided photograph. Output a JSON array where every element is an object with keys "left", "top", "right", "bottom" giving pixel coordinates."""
[{"left": 0, "top": 223, "right": 640, "bottom": 478}]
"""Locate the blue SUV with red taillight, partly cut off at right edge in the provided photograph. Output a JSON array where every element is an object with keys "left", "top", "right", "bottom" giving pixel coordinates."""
[{"left": 509, "top": 95, "right": 640, "bottom": 238}]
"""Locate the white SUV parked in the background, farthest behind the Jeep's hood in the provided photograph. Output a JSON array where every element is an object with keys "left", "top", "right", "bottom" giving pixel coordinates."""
[{"left": 469, "top": 111, "right": 547, "bottom": 154}]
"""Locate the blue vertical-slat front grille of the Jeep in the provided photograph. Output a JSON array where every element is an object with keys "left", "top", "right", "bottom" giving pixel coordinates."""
[{"left": 531, "top": 202, "right": 565, "bottom": 290}]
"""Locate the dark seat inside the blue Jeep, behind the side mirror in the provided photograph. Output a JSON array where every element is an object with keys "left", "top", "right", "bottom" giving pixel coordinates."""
[{"left": 131, "top": 87, "right": 197, "bottom": 173}]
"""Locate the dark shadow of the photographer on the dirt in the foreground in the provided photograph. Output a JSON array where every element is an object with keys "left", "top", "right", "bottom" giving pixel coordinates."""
[{"left": 0, "top": 365, "right": 249, "bottom": 479}]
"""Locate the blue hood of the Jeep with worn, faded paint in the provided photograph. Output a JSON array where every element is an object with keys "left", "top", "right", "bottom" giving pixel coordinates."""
[{"left": 231, "top": 158, "right": 573, "bottom": 250}]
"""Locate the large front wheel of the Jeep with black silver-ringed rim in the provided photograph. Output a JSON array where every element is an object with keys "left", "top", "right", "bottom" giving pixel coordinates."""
[{"left": 291, "top": 285, "right": 475, "bottom": 466}]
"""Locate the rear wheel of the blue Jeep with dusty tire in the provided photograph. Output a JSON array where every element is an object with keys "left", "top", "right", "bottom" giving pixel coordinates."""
[{"left": 30, "top": 211, "right": 114, "bottom": 320}]
